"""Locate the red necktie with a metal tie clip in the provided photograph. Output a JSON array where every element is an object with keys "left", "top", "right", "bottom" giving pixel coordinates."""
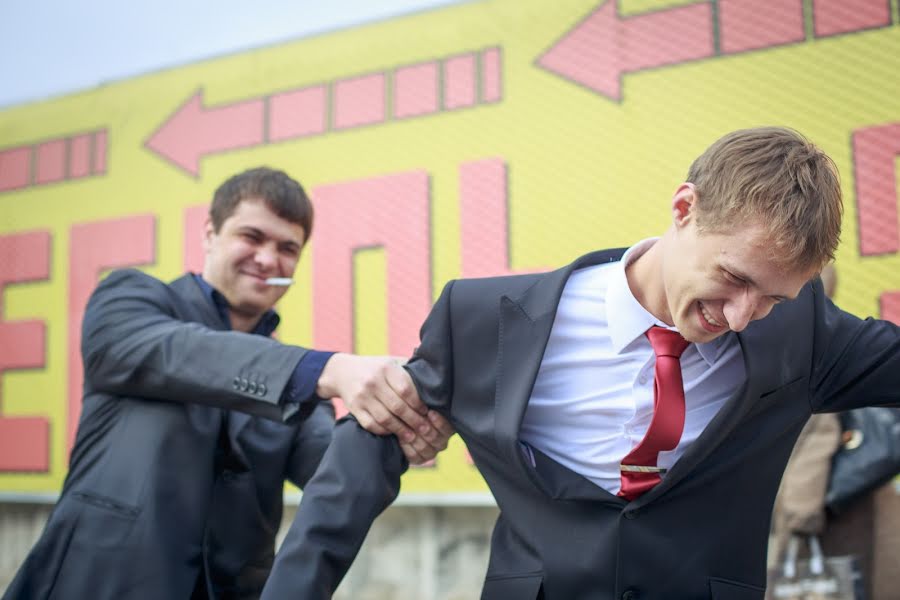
[{"left": 619, "top": 327, "right": 688, "bottom": 500}]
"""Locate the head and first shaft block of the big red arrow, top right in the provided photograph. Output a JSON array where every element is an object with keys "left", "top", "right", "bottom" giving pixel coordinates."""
[{"left": 537, "top": 0, "right": 715, "bottom": 100}]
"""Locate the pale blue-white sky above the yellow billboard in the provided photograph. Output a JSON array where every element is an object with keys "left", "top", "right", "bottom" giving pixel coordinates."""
[{"left": 0, "top": 0, "right": 462, "bottom": 108}]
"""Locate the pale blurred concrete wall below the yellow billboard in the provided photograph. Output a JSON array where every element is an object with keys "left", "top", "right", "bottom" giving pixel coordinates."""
[{"left": 0, "top": 504, "right": 497, "bottom": 600}]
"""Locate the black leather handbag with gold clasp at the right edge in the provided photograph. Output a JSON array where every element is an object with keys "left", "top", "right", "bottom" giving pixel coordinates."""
[{"left": 825, "top": 406, "right": 900, "bottom": 514}]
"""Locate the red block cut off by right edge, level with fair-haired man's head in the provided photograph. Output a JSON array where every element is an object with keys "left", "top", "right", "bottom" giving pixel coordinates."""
[{"left": 853, "top": 123, "right": 900, "bottom": 256}]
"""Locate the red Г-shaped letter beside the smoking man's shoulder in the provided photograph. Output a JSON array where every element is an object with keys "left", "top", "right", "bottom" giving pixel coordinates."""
[{"left": 68, "top": 215, "right": 156, "bottom": 450}]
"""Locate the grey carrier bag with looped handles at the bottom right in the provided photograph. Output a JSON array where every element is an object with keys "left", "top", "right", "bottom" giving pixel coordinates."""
[{"left": 766, "top": 535, "right": 863, "bottom": 600}]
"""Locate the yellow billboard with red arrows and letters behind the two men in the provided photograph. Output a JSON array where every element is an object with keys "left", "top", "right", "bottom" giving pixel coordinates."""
[{"left": 0, "top": 0, "right": 900, "bottom": 498}]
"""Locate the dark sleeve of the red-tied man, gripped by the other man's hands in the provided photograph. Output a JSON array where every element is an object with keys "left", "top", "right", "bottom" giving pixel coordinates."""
[{"left": 262, "top": 284, "right": 453, "bottom": 600}]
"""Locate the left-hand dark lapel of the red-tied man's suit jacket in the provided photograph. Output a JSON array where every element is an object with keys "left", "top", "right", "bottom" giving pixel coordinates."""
[{"left": 495, "top": 250, "right": 624, "bottom": 488}]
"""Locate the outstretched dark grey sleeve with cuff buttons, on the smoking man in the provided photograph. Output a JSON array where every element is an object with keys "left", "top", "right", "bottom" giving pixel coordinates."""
[{"left": 81, "top": 270, "right": 306, "bottom": 421}]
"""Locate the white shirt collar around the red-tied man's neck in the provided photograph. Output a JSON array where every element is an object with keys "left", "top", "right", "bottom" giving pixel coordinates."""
[{"left": 606, "top": 238, "right": 733, "bottom": 366}]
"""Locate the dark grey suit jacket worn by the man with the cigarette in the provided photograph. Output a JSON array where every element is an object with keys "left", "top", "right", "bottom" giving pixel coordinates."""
[{"left": 4, "top": 270, "right": 333, "bottom": 600}]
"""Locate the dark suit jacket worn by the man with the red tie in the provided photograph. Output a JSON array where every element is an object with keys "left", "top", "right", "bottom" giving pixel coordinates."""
[{"left": 263, "top": 250, "right": 900, "bottom": 600}]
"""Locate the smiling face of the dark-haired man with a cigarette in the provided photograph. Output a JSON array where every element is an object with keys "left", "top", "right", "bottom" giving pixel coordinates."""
[{"left": 203, "top": 198, "right": 306, "bottom": 331}]
